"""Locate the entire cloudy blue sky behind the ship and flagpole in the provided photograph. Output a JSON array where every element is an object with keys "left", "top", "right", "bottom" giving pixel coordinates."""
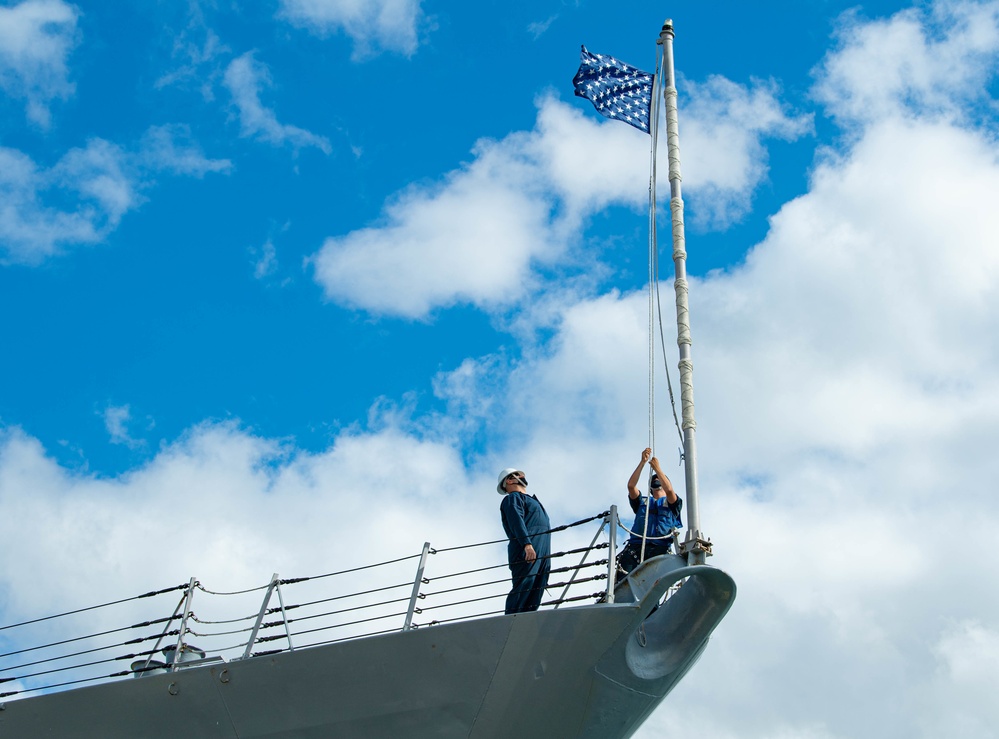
[{"left": 0, "top": 0, "right": 999, "bottom": 739}]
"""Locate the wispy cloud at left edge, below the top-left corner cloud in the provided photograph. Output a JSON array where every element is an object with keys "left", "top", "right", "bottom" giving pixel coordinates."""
[{"left": 0, "top": 126, "right": 231, "bottom": 264}]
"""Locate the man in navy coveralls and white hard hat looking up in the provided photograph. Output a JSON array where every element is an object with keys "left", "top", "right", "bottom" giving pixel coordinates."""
[{"left": 496, "top": 468, "right": 551, "bottom": 613}]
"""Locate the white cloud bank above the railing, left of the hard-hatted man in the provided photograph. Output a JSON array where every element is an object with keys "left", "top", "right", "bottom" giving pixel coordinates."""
[{"left": 0, "top": 422, "right": 498, "bottom": 643}]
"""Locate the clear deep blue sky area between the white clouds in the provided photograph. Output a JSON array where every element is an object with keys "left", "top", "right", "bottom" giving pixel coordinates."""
[{"left": 0, "top": 3, "right": 892, "bottom": 475}]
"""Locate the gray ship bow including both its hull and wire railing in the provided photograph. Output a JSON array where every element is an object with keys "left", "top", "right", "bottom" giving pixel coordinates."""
[{"left": 0, "top": 517, "right": 735, "bottom": 738}]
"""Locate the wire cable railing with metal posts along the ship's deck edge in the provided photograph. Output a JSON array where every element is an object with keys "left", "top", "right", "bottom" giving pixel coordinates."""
[{"left": 0, "top": 508, "right": 636, "bottom": 700}]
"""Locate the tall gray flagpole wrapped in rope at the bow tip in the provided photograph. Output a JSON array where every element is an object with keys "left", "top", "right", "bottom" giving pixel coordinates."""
[{"left": 657, "top": 19, "right": 711, "bottom": 565}]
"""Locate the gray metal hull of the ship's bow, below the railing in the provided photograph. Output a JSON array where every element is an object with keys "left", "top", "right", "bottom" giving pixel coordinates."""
[{"left": 0, "top": 556, "right": 735, "bottom": 739}]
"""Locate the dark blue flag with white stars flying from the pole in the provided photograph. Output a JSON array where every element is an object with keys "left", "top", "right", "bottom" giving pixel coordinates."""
[{"left": 572, "top": 46, "right": 653, "bottom": 133}]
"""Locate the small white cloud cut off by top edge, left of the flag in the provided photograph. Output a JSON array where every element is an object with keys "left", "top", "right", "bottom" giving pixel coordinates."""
[{"left": 278, "top": 0, "right": 423, "bottom": 59}]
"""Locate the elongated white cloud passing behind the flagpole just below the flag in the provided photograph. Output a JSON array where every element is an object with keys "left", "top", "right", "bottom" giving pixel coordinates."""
[{"left": 313, "top": 80, "right": 808, "bottom": 318}]
